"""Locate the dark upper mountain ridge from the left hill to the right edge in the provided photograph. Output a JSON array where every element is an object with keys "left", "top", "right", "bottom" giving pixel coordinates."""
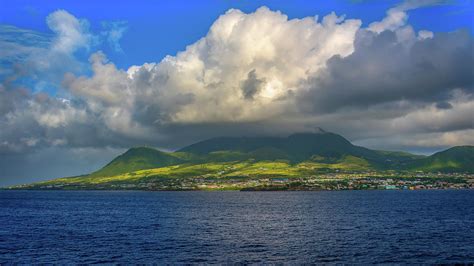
[{"left": 91, "top": 129, "right": 474, "bottom": 176}]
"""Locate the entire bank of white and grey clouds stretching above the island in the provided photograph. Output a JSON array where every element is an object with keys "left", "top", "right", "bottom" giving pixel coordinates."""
[{"left": 0, "top": 4, "right": 474, "bottom": 160}]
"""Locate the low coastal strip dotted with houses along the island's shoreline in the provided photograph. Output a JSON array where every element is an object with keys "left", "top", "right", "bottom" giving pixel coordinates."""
[{"left": 16, "top": 171, "right": 474, "bottom": 190}]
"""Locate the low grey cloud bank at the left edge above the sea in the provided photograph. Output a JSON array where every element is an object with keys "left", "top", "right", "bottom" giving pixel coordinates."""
[{"left": 0, "top": 85, "right": 159, "bottom": 154}]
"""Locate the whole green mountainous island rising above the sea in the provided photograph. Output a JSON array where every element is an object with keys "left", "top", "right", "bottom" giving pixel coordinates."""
[{"left": 12, "top": 130, "right": 474, "bottom": 190}]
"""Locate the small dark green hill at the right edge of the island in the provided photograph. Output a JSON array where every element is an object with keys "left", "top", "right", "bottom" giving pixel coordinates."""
[{"left": 409, "top": 146, "right": 474, "bottom": 172}]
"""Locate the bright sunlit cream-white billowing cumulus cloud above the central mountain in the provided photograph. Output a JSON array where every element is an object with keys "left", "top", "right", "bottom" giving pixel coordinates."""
[{"left": 65, "top": 7, "right": 360, "bottom": 128}]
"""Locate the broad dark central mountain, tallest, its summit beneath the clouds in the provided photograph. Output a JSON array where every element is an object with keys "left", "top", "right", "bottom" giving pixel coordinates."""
[{"left": 178, "top": 130, "right": 417, "bottom": 168}]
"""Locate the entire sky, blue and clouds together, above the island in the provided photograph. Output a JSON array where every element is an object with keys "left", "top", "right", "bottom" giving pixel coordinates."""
[{"left": 0, "top": 0, "right": 474, "bottom": 186}]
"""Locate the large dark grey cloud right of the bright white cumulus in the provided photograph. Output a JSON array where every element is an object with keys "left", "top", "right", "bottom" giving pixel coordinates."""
[{"left": 300, "top": 31, "right": 474, "bottom": 113}]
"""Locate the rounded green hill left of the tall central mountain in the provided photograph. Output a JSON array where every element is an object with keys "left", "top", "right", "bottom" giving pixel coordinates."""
[{"left": 90, "top": 147, "right": 183, "bottom": 176}]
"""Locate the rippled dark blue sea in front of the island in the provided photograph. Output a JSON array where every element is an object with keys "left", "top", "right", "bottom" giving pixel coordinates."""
[{"left": 0, "top": 190, "right": 474, "bottom": 263}]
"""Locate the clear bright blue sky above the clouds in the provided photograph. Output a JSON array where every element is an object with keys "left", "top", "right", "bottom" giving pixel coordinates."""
[{"left": 0, "top": 0, "right": 474, "bottom": 68}]
